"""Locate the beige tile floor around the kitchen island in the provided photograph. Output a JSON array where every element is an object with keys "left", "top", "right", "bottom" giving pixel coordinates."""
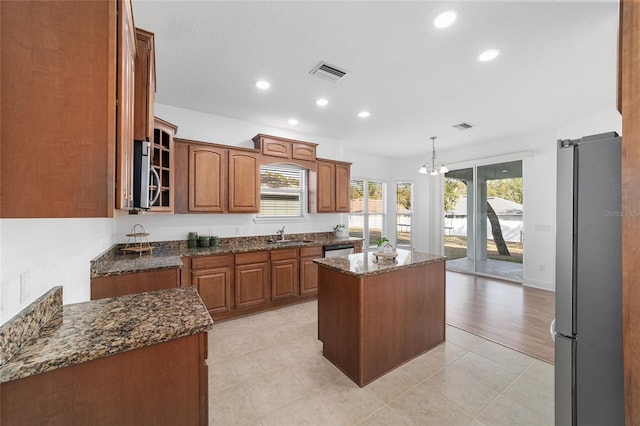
[{"left": 209, "top": 301, "right": 553, "bottom": 426}]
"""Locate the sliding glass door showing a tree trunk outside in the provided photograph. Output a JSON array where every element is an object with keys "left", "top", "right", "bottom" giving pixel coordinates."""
[{"left": 444, "top": 160, "right": 524, "bottom": 282}]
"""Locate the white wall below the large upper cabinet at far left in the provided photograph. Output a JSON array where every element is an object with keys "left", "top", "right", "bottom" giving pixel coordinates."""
[{"left": 0, "top": 218, "right": 114, "bottom": 324}]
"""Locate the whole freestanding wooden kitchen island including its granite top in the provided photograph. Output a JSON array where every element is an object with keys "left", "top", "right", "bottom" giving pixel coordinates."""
[{"left": 314, "top": 250, "right": 445, "bottom": 387}]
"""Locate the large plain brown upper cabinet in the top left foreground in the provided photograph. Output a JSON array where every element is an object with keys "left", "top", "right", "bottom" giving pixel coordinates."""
[{"left": 0, "top": 0, "right": 121, "bottom": 218}]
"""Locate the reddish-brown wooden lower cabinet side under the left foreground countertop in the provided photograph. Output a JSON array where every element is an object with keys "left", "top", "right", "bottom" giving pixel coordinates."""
[{"left": 0, "top": 333, "right": 208, "bottom": 426}]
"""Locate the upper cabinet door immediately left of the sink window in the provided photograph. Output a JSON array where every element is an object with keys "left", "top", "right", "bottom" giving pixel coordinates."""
[{"left": 229, "top": 150, "right": 260, "bottom": 213}]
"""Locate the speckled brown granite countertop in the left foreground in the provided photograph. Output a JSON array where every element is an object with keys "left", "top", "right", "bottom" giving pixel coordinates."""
[{"left": 0, "top": 286, "right": 213, "bottom": 383}]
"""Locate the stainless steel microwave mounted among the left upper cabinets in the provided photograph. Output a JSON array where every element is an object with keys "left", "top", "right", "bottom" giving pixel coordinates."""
[{"left": 133, "top": 141, "right": 160, "bottom": 209}]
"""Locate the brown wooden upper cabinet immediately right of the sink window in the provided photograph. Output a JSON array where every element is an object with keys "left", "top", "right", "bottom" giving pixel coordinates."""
[{"left": 309, "top": 160, "right": 351, "bottom": 213}]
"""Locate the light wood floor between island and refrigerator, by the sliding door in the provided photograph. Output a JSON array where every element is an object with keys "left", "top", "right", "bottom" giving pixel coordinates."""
[{"left": 447, "top": 271, "right": 555, "bottom": 364}]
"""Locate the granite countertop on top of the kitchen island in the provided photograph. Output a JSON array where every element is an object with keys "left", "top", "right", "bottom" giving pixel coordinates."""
[{"left": 313, "top": 249, "right": 445, "bottom": 277}]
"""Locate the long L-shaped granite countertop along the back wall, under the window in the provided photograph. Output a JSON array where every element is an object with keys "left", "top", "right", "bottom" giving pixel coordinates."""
[{"left": 91, "top": 232, "right": 362, "bottom": 278}]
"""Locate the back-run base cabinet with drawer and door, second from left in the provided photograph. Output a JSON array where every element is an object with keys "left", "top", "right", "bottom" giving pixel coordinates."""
[{"left": 234, "top": 251, "right": 270, "bottom": 309}]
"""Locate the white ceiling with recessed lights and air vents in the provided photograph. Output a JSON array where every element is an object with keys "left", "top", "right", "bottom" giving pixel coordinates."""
[{"left": 133, "top": 0, "right": 618, "bottom": 157}]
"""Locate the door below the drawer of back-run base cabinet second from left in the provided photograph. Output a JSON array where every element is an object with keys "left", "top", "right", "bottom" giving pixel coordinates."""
[{"left": 234, "top": 263, "right": 269, "bottom": 309}]
